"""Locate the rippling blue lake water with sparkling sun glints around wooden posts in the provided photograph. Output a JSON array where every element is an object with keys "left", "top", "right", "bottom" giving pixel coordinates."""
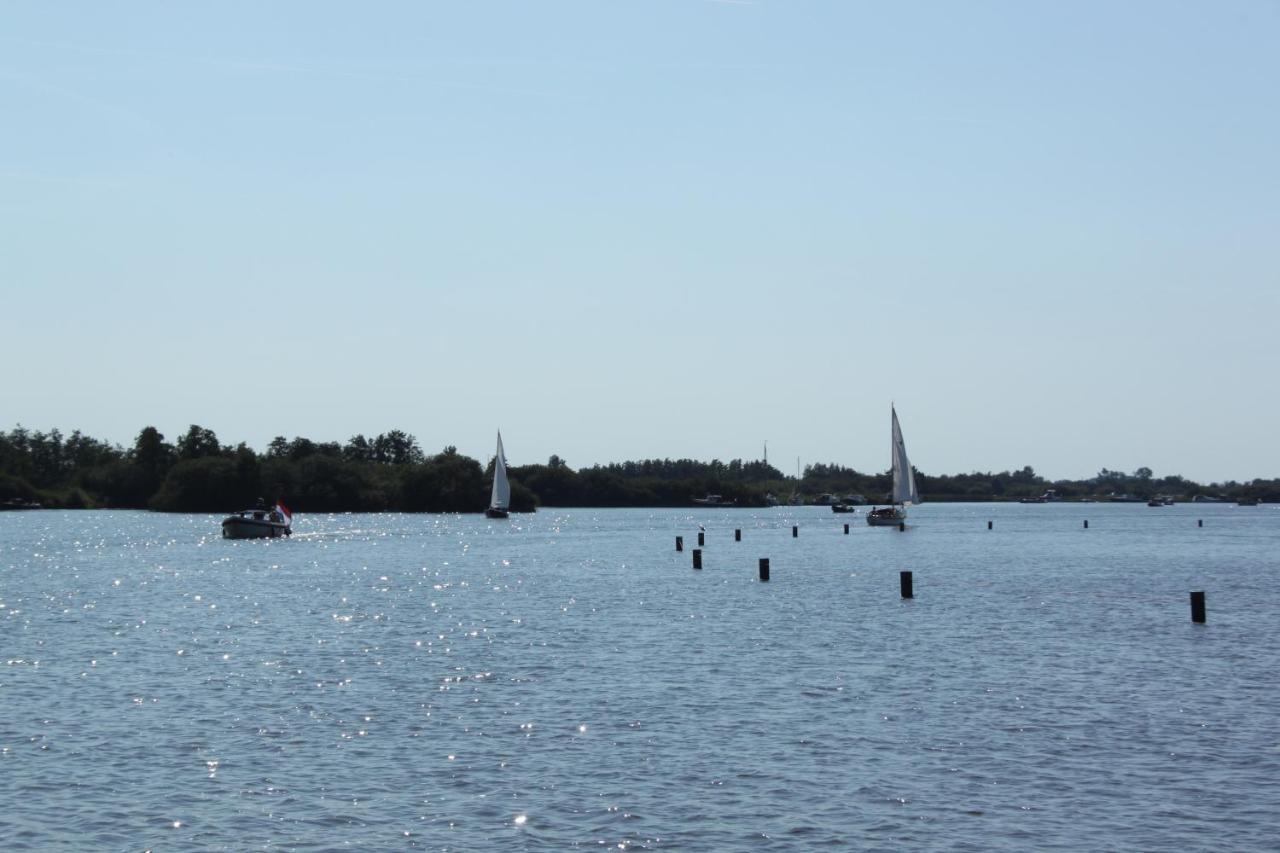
[{"left": 0, "top": 503, "right": 1280, "bottom": 850}]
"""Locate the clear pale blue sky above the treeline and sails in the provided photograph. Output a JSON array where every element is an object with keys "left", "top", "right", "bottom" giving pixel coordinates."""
[{"left": 0, "top": 0, "right": 1280, "bottom": 482}]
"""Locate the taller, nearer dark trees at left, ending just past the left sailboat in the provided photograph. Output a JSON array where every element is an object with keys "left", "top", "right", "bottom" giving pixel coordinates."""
[{"left": 0, "top": 425, "right": 535, "bottom": 512}]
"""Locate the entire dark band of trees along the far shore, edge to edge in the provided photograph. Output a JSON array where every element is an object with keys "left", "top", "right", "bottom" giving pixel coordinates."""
[{"left": 0, "top": 424, "right": 1280, "bottom": 512}]
